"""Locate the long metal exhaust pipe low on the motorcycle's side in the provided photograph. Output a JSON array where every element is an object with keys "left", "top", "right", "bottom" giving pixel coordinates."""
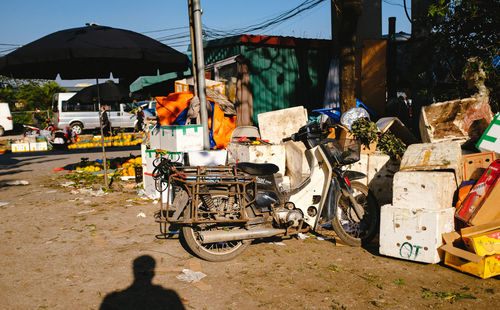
[{"left": 199, "top": 228, "right": 286, "bottom": 244}]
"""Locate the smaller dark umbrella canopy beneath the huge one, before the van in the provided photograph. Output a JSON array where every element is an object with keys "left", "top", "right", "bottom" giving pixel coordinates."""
[{"left": 68, "top": 81, "right": 142, "bottom": 104}]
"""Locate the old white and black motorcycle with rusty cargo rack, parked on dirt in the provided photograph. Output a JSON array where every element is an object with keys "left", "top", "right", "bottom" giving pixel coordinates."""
[{"left": 152, "top": 123, "right": 379, "bottom": 261}]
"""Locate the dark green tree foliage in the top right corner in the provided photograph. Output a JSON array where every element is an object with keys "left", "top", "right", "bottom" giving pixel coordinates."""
[{"left": 420, "top": 0, "right": 500, "bottom": 105}]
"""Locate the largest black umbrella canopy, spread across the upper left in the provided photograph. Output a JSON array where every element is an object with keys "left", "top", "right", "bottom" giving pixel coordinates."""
[{"left": 0, "top": 25, "right": 189, "bottom": 80}]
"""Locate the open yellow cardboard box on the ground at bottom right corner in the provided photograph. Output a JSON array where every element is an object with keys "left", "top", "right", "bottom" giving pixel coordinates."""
[{"left": 441, "top": 232, "right": 500, "bottom": 279}]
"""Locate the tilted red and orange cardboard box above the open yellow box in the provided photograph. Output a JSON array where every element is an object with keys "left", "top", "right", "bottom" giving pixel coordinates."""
[{"left": 455, "top": 160, "right": 500, "bottom": 226}]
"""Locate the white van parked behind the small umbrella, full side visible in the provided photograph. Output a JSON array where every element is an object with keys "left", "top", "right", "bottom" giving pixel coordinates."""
[{"left": 52, "top": 93, "right": 137, "bottom": 134}]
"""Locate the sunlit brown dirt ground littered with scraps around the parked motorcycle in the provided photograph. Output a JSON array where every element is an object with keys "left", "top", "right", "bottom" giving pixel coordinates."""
[{"left": 0, "top": 149, "right": 500, "bottom": 310}]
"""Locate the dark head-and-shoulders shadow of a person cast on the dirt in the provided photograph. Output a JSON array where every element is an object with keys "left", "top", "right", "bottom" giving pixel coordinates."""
[{"left": 99, "top": 255, "right": 185, "bottom": 310}]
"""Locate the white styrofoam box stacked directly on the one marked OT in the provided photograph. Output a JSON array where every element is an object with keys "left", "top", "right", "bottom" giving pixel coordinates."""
[{"left": 392, "top": 171, "right": 457, "bottom": 210}]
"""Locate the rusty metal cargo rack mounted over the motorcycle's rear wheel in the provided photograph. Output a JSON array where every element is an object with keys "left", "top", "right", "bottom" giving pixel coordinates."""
[{"left": 156, "top": 166, "right": 257, "bottom": 224}]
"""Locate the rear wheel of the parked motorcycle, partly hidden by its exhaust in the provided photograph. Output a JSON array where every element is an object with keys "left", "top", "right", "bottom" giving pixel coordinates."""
[{"left": 181, "top": 195, "right": 252, "bottom": 262}]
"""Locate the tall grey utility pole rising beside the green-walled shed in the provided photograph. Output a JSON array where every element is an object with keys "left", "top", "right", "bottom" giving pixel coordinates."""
[{"left": 188, "top": 0, "right": 210, "bottom": 150}]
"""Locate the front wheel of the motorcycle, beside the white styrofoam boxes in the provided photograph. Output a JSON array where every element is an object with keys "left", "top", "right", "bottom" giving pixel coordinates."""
[{"left": 332, "top": 182, "right": 380, "bottom": 246}]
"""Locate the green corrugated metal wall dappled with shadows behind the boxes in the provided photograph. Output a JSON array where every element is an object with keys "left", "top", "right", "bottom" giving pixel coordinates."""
[{"left": 204, "top": 40, "right": 330, "bottom": 123}]
